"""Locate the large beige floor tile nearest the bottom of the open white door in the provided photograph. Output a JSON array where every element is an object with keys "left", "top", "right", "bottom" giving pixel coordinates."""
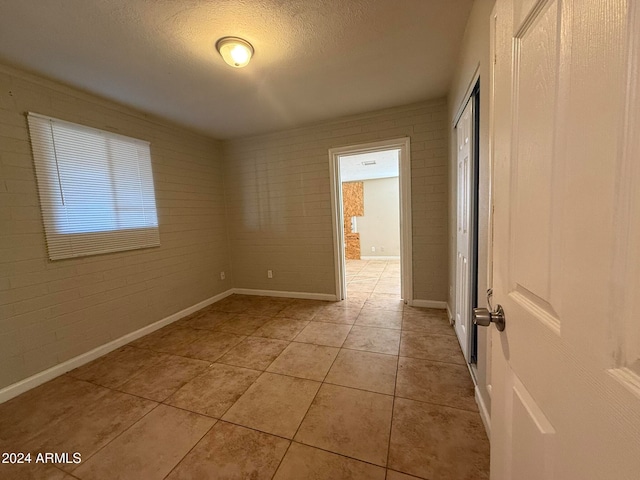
[{"left": 389, "top": 398, "right": 489, "bottom": 480}]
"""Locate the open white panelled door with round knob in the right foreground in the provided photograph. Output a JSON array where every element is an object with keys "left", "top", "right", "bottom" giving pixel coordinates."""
[{"left": 490, "top": 0, "right": 640, "bottom": 480}]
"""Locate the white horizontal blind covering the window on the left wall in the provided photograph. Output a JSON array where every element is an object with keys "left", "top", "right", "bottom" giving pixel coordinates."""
[{"left": 28, "top": 113, "right": 160, "bottom": 260}]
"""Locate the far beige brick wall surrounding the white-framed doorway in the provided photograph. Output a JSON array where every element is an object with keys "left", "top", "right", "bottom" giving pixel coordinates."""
[{"left": 223, "top": 99, "right": 448, "bottom": 301}]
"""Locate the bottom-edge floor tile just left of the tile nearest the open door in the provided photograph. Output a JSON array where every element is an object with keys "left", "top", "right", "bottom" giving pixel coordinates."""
[{"left": 273, "top": 442, "right": 385, "bottom": 480}]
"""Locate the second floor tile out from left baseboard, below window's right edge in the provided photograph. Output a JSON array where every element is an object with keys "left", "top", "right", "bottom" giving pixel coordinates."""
[{"left": 118, "top": 355, "right": 210, "bottom": 402}]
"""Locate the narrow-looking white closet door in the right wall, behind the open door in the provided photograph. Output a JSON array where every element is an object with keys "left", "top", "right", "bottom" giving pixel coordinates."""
[{"left": 455, "top": 100, "right": 473, "bottom": 361}]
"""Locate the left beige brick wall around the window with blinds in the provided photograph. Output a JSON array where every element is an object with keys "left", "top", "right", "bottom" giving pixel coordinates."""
[{"left": 0, "top": 67, "right": 233, "bottom": 388}]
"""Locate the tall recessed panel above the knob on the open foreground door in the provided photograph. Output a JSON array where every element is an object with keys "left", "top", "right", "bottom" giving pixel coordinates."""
[{"left": 511, "top": 1, "right": 561, "bottom": 317}]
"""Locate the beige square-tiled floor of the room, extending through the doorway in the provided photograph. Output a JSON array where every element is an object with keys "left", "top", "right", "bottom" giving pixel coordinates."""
[{"left": 0, "top": 261, "right": 489, "bottom": 480}]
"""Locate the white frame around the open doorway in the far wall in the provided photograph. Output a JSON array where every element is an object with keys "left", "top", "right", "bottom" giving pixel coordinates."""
[{"left": 329, "top": 137, "right": 413, "bottom": 305}]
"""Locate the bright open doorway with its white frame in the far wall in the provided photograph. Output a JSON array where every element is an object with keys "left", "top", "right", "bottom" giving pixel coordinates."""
[{"left": 329, "top": 138, "right": 413, "bottom": 304}]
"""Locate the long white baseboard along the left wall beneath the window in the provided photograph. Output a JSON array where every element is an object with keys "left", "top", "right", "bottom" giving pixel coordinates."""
[{"left": 0, "top": 289, "right": 234, "bottom": 403}]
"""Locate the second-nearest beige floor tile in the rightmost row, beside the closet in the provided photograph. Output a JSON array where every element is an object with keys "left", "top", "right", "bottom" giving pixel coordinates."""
[{"left": 396, "top": 357, "right": 478, "bottom": 411}]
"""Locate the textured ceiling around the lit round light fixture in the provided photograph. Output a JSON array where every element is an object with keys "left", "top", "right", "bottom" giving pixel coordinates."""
[{"left": 0, "top": 0, "right": 472, "bottom": 138}]
